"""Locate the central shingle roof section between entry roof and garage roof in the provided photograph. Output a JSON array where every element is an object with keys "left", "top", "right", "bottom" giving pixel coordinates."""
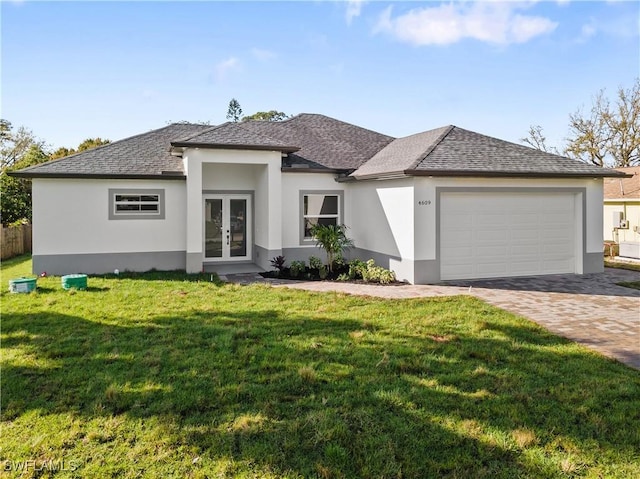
[{"left": 242, "top": 113, "right": 393, "bottom": 170}]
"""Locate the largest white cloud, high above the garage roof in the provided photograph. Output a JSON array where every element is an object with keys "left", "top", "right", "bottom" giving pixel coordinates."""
[{"left": 374, "top": 2, "right": 558, "bottom": 45}]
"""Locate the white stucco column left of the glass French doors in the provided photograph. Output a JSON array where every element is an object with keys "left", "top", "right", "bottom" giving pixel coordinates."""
[{"left": 183, "top": 150, "right": 203, "bottom": 273}]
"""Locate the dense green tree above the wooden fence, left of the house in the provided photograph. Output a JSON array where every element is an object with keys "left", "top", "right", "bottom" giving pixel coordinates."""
[{"left": 0, "top": 143, "right": 49, "bottom": 225}]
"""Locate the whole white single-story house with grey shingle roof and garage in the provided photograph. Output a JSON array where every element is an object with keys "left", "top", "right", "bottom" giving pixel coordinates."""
[{"left": 14, "top": 114, "right": 625, "bottom": 284}]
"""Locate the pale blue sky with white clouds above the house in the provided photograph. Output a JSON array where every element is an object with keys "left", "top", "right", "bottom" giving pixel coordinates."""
[{"left": 0, "top": 0, "right": 640, "bottom": 151}]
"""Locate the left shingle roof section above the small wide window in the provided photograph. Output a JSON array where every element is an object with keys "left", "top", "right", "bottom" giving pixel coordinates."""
[{"left": 12, "top": 123, "right": 211, "bottom": 178}]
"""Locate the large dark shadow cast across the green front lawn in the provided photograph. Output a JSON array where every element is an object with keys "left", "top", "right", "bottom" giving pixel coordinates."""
[{"left": 2, "top": 303, "right": 640, "bottom": 477}]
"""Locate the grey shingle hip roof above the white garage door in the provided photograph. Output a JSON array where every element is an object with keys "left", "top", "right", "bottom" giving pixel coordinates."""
[{"left": 351, "top": 126, "right": 621, "bottom": 179}]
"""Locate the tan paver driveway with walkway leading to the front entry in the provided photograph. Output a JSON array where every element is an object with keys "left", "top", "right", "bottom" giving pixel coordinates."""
[{"left": 227, "top": 268, "right": 640, "bottom": 369}]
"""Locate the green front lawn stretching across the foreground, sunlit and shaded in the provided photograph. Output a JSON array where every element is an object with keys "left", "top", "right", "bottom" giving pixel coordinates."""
[{"left": 0, "top": 253, "right": 640, "bottom": 479}]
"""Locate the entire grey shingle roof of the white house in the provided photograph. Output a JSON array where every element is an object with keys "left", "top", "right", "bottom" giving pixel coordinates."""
[{"left": 10, "top": 113, "right": 626, "bottom": 180}]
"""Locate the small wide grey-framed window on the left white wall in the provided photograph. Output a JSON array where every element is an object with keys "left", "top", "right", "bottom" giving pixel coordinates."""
[{"left": 109, "top": 189, "right": 164, "bottom": 220}]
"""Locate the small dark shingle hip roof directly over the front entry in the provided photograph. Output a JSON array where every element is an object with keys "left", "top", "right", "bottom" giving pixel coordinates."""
[{"left": 171, "top": 122, "right": 298, "bottom": 151}]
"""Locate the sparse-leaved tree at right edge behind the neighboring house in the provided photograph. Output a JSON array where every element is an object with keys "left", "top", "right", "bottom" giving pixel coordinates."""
[{"left": 565, "top": 79, "right": 640, "bottom": 167}]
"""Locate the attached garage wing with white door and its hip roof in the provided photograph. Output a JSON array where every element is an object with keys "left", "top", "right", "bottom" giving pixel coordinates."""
[{"left": 348, "top": 125, "right": 621, "bottom": 284}]
